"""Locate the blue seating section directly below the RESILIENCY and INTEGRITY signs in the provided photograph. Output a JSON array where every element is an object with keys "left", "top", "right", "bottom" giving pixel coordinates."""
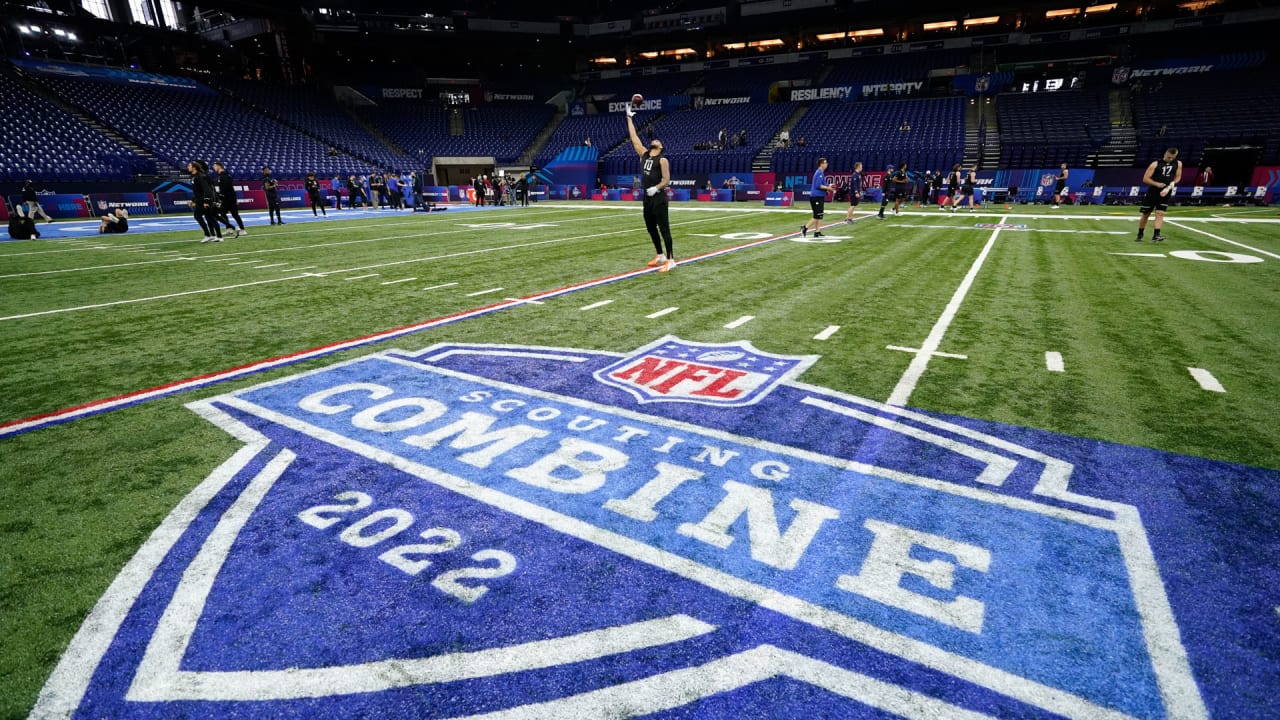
[{"left": 773, "top": 97, "right": 965, "bottom": 173}]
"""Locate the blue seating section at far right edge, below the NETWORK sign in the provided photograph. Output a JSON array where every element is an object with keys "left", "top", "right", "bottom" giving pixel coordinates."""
[{"left": 1132, "top": 69, "right": 1280, "bottom": 165}]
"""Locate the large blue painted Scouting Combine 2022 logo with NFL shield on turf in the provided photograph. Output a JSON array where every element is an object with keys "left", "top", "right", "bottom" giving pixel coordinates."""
[{"left": 33, "top": 337, "right": 1274, "bottom": 720}]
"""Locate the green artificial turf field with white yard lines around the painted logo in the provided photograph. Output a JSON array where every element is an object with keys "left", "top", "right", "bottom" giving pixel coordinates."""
[{"left": 0, "top": 204, "right": 1280, "bottom": 717}]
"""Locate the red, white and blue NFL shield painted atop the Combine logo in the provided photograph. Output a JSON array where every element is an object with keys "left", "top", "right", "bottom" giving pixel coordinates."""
[{"left": 595, "top": 336, "right": 818, "bottom": 407}]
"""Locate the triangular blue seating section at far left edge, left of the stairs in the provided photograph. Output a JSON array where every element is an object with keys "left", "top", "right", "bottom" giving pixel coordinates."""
[{"left": 0, "top": 72, "right": 146, "bottom": 182}]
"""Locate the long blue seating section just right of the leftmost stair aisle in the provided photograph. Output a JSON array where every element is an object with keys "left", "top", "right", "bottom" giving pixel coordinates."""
[{"left": 42, "top": 77, "right": 374, "bottom": 177}]
